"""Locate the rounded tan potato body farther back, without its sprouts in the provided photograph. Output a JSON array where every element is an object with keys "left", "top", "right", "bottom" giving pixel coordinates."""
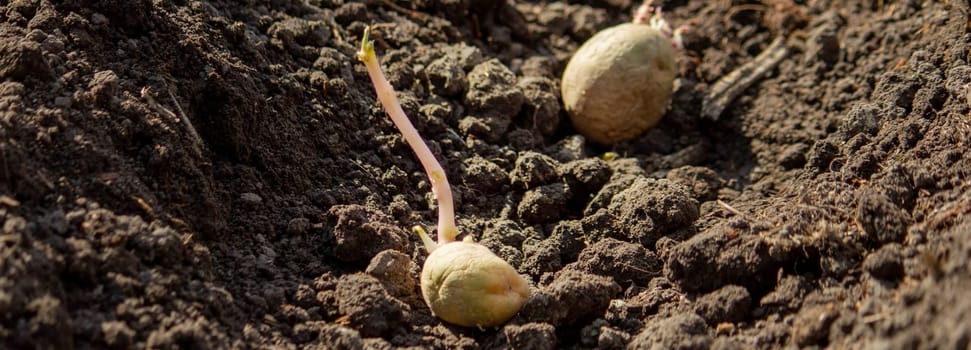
[{"left": 560, "top": 23, "right": 677, "bottom": 145}]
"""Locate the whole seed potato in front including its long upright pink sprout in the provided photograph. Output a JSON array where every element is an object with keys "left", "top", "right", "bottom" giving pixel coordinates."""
[{"left": 357, "top": 28, "right": 529, "bottom": 328}]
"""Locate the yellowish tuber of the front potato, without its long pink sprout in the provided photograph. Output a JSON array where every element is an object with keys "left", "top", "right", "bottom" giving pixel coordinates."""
[{"left": 421, "top": 242, "right": 529, "bottom": 328}]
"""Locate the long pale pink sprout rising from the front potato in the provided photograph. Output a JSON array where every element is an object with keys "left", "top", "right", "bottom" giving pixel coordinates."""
[{"left": 357, "top": 27, "right": 459, "bottom": 248}]
